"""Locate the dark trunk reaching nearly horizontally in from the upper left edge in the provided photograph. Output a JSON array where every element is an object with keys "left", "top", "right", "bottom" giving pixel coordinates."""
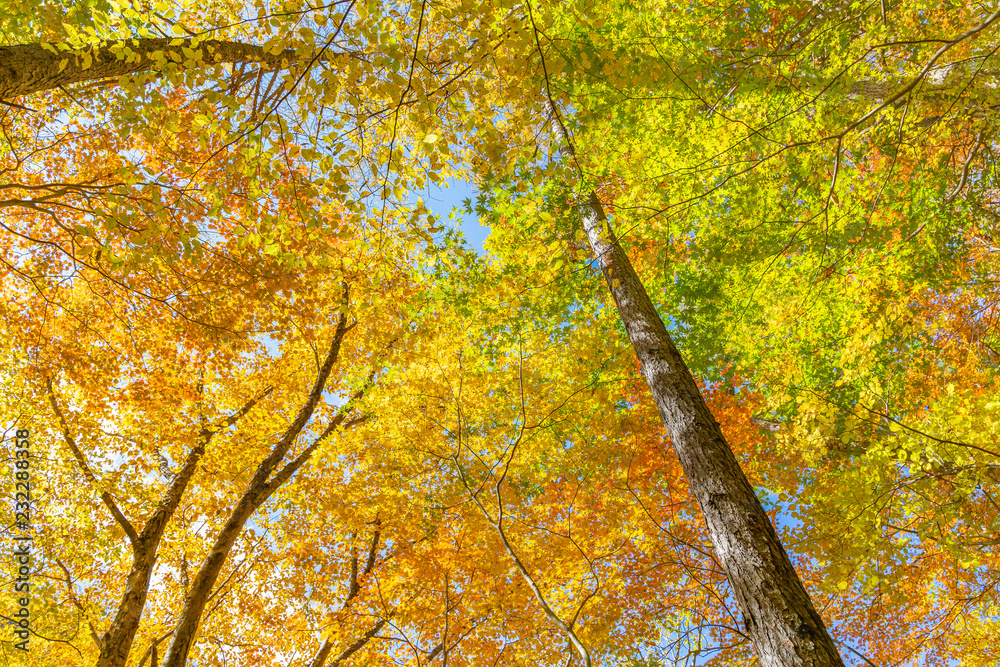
[{"left": 0, "top": 38, "right": 337, "bottom": 99}]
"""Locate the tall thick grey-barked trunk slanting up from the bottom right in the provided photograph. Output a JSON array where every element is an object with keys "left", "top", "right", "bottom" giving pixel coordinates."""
[{"left": 548, "top": 101, "right": 843, "bottom": 667}]
